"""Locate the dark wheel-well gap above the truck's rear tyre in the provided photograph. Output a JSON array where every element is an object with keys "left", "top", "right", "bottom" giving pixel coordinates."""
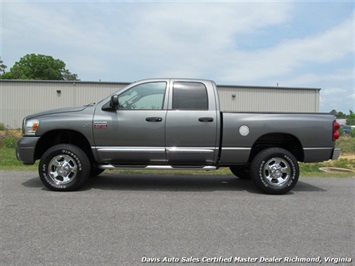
[{"left": 248, "top": 133, "right": 304, "bottom": 162}]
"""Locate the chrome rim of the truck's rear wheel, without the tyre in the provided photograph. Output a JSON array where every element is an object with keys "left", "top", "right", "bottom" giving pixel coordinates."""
[{"left": 262, "top": 157, "right": 291, "bottom": 186}]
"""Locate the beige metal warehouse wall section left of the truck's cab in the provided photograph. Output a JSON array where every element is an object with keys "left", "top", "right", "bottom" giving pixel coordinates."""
[{"left": 0, "top": 81, "right": 127, "bottom": 128}]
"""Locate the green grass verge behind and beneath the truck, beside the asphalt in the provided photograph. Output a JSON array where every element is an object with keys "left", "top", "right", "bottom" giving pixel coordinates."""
[{"left": 0, "top": 137, "right": 355, "bottom": 177}]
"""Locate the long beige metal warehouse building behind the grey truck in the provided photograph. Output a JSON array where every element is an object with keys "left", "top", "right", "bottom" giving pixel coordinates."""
[{"left": 0, "top": 80, "right": 320, "bottom": 128}]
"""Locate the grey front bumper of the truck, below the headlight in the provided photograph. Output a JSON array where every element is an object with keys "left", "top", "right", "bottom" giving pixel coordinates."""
[{"left": 16, "top": 136, "right": 40, "bottom": 164}]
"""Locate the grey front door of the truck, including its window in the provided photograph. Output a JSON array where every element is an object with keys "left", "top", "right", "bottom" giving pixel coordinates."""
[{"left": 94, "top": 81, "right": 167, "bottom": 165}]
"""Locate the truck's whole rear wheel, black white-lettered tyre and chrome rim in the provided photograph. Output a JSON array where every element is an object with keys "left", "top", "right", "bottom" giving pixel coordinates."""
[{"left": 250, "top": 148, "right": 299, "bottom": 194}]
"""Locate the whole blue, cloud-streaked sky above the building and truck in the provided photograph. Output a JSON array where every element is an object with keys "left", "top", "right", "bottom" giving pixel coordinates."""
[{"left": 0, "top": 1, "right": 355, "bottom": 113}]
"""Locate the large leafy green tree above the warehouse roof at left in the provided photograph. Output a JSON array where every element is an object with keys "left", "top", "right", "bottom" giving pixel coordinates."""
[{"left": 0, "top": 54, "right": 78, "bottom": 80}]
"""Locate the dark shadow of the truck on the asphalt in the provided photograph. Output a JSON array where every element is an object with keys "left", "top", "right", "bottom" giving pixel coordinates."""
[{"left": 22, "top": 173, "right": 326, "bottom": 194}]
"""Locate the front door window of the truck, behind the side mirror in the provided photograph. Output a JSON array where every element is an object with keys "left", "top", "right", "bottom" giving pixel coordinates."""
[{"left": 118, "top": 82, "right": 166, "bottom": 110}]
